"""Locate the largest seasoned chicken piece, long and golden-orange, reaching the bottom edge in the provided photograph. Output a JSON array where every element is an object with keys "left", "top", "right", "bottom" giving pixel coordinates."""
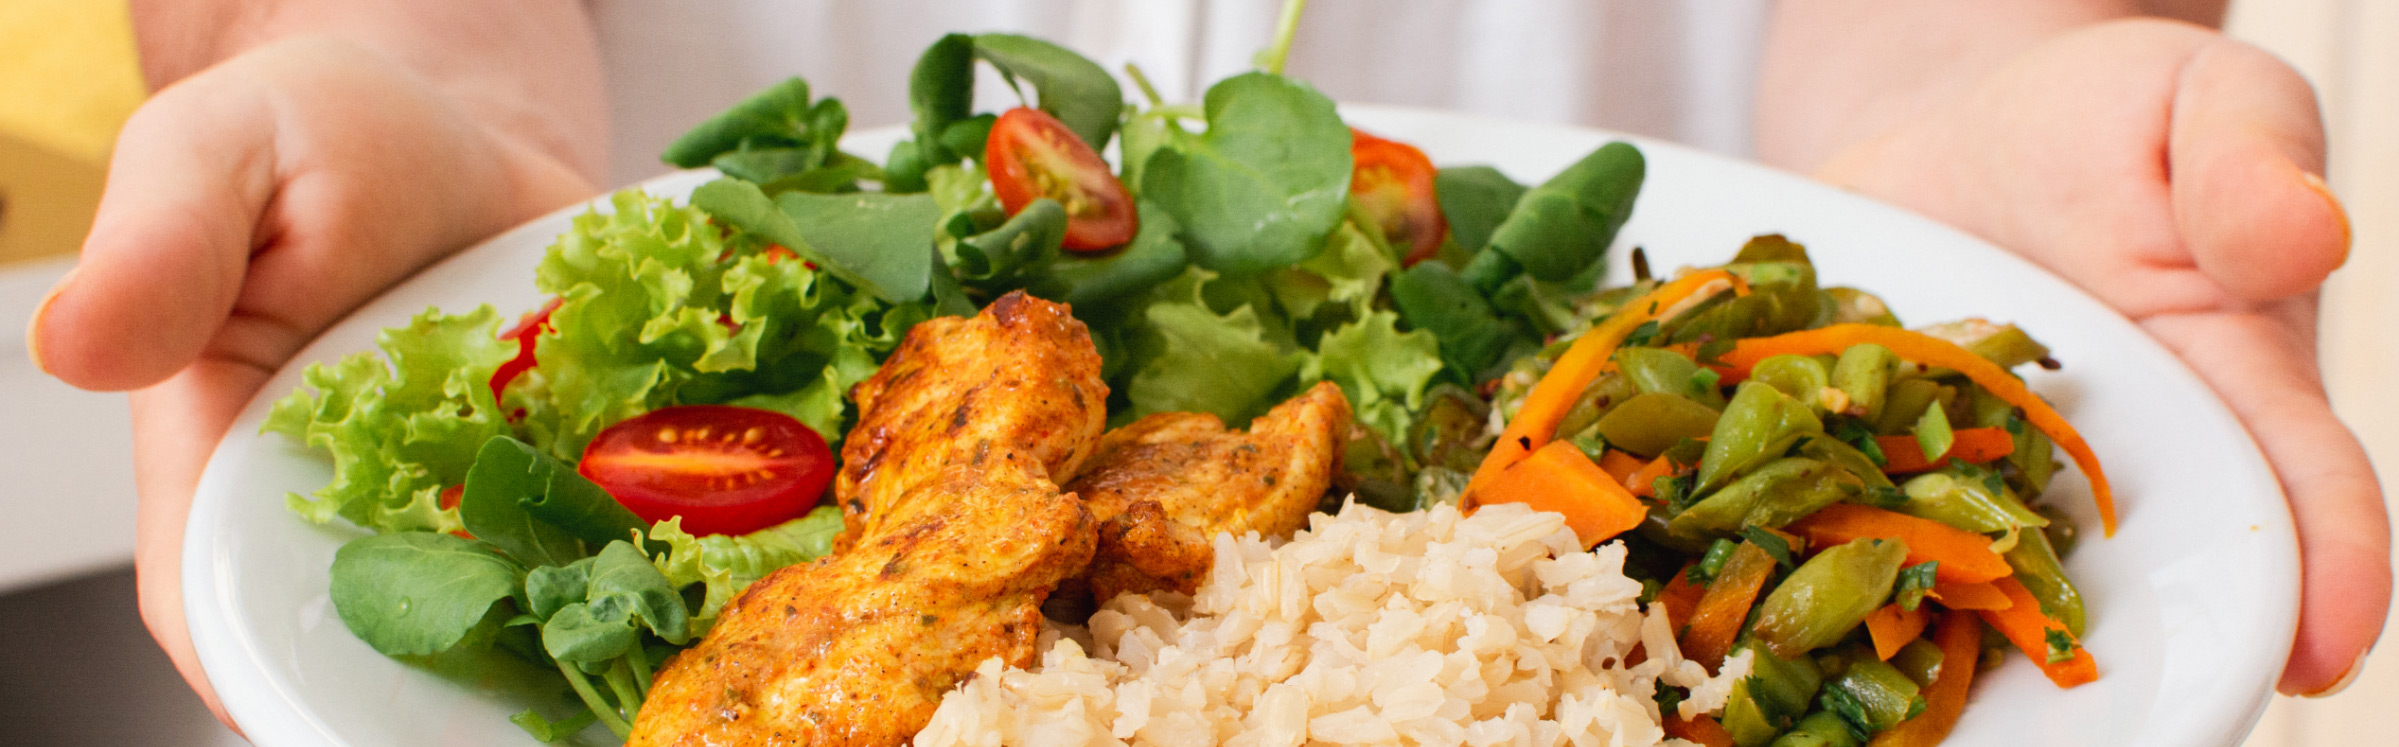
[{"left": 629, "top": 293, "right": 1108, "bottom": 747}]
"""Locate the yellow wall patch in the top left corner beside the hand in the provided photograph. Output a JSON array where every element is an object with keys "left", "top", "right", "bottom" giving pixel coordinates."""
[{"left": 0, "top": 0, "right": 146, "bottom": 264}]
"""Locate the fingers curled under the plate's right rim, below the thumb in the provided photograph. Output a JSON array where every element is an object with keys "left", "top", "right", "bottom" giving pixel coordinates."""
[{"left": 2142, "top": 309, "right": 2392, "bottom": 694}]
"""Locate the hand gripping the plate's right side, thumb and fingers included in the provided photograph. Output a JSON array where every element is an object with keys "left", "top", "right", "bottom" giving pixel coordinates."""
[{"left": 1770, "top": 19, "right": 2392, "bottom": 694}]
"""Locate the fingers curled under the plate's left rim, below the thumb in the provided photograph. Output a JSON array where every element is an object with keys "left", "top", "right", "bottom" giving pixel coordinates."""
[{"left": 132, "top": 360, "right": 271, "bottom": 733}]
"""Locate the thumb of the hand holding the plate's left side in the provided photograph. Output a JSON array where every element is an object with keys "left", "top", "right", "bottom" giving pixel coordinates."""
[{"left": 26, "top": 67, "right": 273, "bottom": 389}]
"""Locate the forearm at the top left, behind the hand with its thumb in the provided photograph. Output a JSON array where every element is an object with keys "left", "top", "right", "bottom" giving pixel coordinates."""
[{"left": 130, "top": 0, "right": 609, "bottom": 183}]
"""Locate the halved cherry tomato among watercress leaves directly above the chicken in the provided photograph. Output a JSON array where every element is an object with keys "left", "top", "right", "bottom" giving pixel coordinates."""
[{"left": 984, "top": 106, "right": 1140, "bottom": 252}]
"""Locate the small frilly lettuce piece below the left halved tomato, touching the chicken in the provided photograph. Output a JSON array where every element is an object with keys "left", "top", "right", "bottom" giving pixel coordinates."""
[{"left": 650, "top": 507, "right": 842, "bottom": 634}]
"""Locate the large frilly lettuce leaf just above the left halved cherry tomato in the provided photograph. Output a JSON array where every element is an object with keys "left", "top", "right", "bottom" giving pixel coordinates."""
[{"left": 509, "top": 190, "right": 931, "bottom": 459}]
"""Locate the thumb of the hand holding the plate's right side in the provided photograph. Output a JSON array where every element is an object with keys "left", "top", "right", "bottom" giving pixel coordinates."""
[{"left": 2169, "top": 38, "right": 2349, "bottom": 300}]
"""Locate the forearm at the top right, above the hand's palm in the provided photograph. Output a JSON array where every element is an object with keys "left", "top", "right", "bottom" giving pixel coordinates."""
[{"left": 1756, "top": 0, "right": 2226, "bottom": 171}]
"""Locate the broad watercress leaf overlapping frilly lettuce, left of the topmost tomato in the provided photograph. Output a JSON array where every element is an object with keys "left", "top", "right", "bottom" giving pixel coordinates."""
[{"left": 775, "top": 192, "right": 940, "bottom": 303}]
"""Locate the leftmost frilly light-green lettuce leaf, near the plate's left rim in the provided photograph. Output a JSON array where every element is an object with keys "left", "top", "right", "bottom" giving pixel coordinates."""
[{"left": 261, "top": 305, "right": 516, "bottom": 531}]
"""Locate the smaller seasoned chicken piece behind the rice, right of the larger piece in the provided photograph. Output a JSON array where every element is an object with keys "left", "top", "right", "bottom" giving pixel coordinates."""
[{"left": 1068, "top": 382, "right": 1351, "bottom": 600}]
